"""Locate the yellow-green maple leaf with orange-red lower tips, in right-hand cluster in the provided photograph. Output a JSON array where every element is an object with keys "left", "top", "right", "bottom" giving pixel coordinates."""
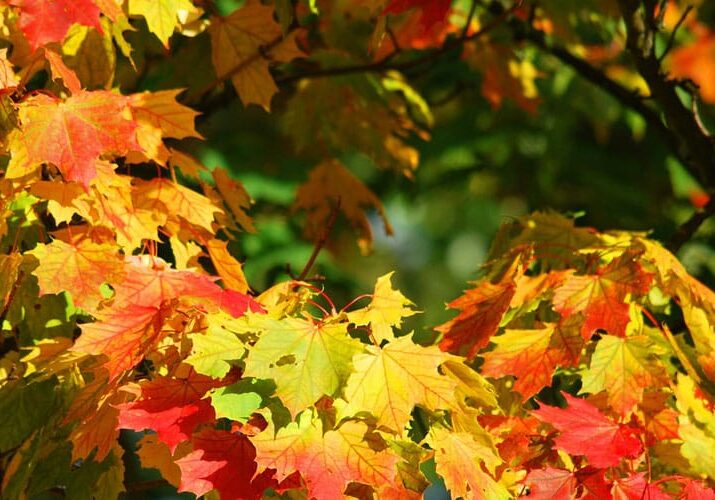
[{"left": 581, "top": 335, "right": 667, "bottom": 416}]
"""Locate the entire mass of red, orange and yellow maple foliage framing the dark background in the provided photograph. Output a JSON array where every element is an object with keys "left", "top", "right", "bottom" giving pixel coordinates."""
[{"left": 0, "top": 0, "right": 715, "bottom": 499}]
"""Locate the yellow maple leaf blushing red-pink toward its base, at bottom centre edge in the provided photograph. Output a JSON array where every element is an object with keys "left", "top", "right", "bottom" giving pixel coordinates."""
[{"left": 251, "top": 411, "right": 398, "bottom": 499}]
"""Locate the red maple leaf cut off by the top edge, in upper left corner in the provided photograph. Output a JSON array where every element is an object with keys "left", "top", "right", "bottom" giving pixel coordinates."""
[{"left": 10, "top": 0, "right": 102, "bottom": 51}]
